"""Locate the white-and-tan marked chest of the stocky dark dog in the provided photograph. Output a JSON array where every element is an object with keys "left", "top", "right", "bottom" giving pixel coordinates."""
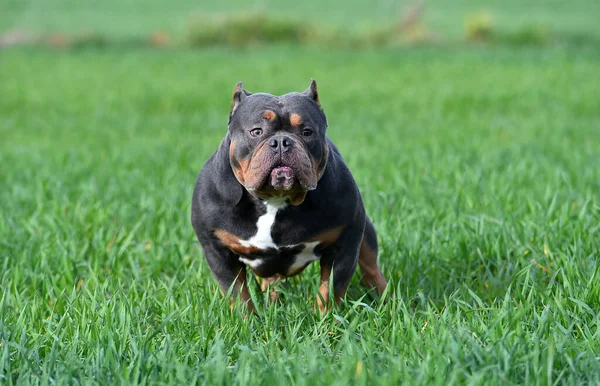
[{"left": 215, "top": 201, "right": 339, "bottom": 277}]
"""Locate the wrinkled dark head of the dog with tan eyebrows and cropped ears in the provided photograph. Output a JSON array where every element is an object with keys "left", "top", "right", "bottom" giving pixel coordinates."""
[{"left": 229, "top": 80, "right": 329, "bottom": 205}]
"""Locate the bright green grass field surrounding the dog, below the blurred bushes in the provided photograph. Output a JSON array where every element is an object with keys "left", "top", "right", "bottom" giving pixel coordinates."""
[{"left": 0, "top": 47, "right": 600, "bottom": 385}]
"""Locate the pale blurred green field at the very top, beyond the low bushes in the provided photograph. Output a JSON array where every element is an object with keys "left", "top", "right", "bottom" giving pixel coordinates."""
[{"left": 0, "top": 0, "right": 600, "bottom": 37}]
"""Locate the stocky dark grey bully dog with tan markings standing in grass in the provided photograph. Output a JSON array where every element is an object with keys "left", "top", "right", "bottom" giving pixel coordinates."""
[{"left": 191, "top": 79, "right": 387, "bottom": 313}]
